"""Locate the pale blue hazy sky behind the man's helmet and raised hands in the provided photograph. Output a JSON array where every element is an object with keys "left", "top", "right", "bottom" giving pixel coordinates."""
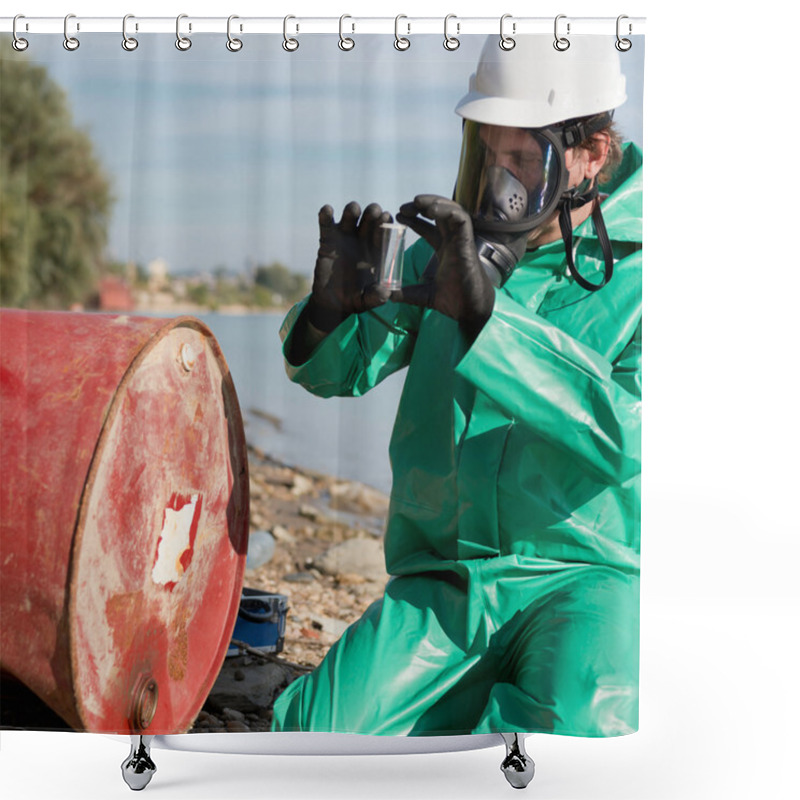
[{"left": 12, "top": 34, "right": 644, "bottom": 275}]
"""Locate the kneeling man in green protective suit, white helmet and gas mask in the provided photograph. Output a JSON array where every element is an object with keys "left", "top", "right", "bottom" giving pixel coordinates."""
[{"left": 274, "top": 32, "right": 641, "bottom": 736}]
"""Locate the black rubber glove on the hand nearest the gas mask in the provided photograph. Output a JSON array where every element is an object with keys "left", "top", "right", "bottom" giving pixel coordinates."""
[{"left": 392, "top": 194, "right": 494, "bottom": 343}]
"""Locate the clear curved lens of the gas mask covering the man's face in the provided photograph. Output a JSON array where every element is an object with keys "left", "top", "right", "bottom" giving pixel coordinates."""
[{"left": 454, "top": 120, "right": 561, "bottom": 229}]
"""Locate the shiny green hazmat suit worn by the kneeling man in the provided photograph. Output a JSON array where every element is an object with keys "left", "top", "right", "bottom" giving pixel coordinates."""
[{"left": 273, "top": 145, "right": 641, "bottom": 736}]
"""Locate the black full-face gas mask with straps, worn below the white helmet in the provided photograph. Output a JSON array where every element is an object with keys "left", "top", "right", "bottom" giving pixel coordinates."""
[{"left": 453, "top": 113, "right": 613, "bottom": 291}]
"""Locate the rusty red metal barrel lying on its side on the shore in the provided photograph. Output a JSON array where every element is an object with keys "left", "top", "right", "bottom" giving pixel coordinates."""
[{"left": 0, "top": 310, "right": 248, "bottom": 733}]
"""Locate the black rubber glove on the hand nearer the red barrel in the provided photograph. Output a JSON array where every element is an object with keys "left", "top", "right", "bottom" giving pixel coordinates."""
[{"left": 307, "top": 202, "right": 392, "bottom": 333}]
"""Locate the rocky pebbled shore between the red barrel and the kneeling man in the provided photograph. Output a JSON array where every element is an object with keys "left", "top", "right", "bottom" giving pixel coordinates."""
[{"left": 190, "top": 446, "right": 389, "bottom": 733}]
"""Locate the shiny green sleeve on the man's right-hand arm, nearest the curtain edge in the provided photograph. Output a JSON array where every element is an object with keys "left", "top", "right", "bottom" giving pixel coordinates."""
[{"left": 457, "top": 292, "right": 641, "bottom": 484}]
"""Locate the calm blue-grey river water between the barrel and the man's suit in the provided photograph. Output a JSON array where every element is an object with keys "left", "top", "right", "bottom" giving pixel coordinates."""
[{"left": 195, "top": 313, "right": 405, "bottom": 493}]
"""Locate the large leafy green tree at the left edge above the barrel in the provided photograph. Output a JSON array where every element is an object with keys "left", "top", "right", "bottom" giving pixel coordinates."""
[{"left": 0, "top": 42, "right": 112, "bottom": 307}]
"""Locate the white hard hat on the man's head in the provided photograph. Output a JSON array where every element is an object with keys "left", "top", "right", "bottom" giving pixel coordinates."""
[{"left": 456, "top": 34, "right": 626, "bottom": 128}]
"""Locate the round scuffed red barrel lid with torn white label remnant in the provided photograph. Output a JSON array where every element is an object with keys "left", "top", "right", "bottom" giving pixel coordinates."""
[{"left": 69, "top": 318, "right": 248, "bottom": 734}]
